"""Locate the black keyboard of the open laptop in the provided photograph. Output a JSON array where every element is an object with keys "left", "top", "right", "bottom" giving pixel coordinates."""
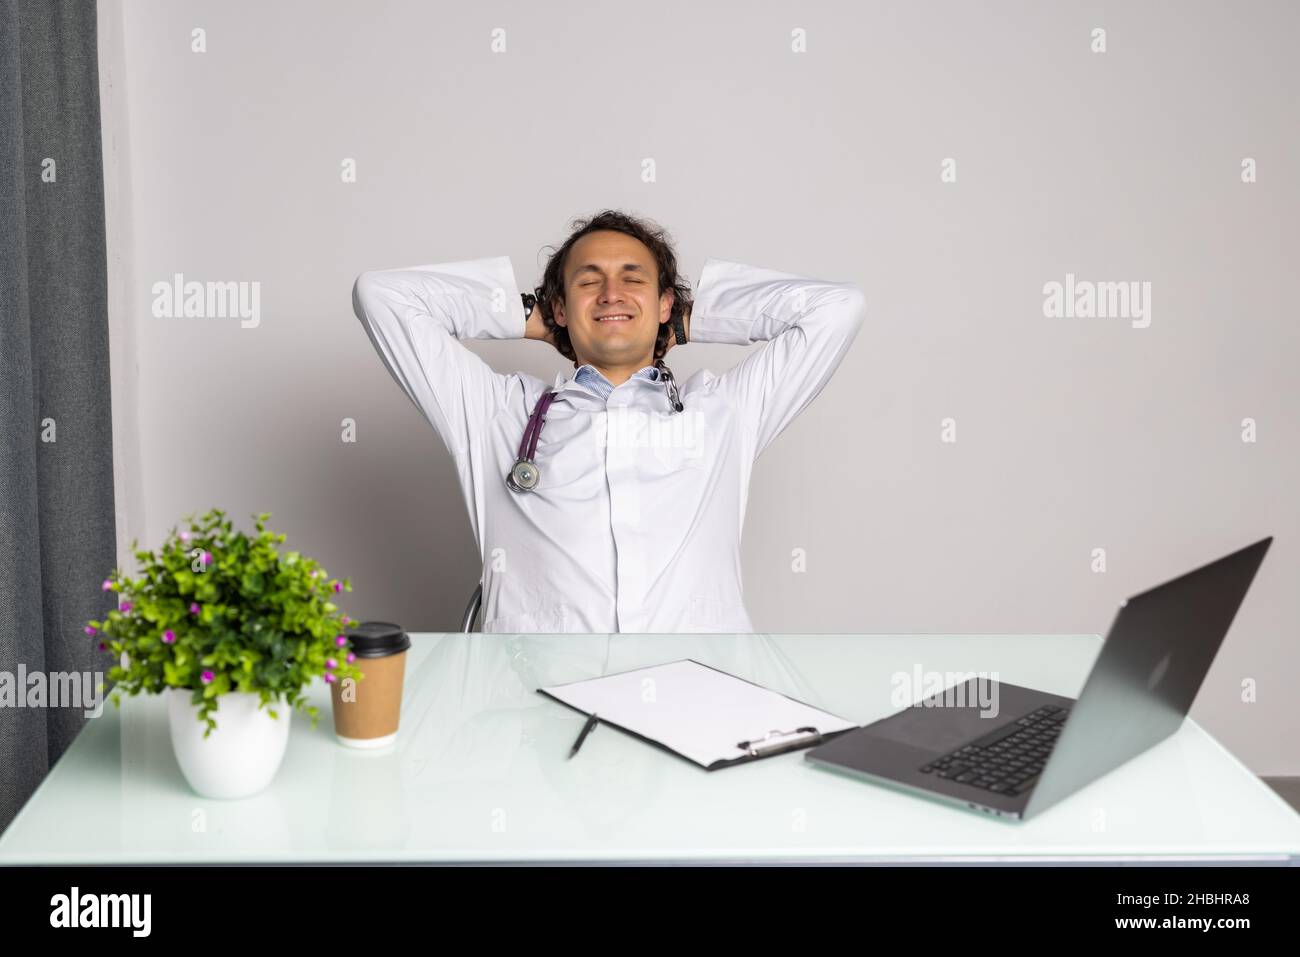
[{"left": 920, "top": 705, "right": 1070, "bottom": 794}]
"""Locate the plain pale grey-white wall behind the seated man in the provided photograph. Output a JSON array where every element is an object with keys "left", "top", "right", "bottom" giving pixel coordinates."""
[{"left": 100, "top": 0, "right": 1300, "bottom": 774}]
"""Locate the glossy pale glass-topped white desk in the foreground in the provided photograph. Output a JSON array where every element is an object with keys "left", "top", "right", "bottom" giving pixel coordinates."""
[{"left": 0, "top": 633, "right": 1300, "bottom": 863}]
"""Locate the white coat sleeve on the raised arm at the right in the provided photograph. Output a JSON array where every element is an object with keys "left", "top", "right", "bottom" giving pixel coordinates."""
[{"left": 690, "top": 259, "right": 867, "bottom": 458}]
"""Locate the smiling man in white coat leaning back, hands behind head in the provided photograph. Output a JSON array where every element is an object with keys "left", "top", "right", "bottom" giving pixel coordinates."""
[{"left": 352, "top": 209, "right": 866, "bottom": 635}]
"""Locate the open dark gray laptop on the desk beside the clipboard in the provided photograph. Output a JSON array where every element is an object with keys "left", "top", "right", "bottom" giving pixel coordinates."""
[{"left": 805, "top": 536, "right": 1273, "bottom": 820}]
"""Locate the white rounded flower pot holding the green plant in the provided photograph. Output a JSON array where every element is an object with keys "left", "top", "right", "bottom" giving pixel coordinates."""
[{"left": 165, "top": 688, "right": 293, "bottom": 798}]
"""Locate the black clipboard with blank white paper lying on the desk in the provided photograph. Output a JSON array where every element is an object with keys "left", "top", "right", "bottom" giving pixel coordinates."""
[{"left": 537, "top": 658, "right": 858, "bottom": 771}]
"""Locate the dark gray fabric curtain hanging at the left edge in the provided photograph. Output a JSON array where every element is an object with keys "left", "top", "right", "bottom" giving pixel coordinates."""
[{"left": 0, "top": 0, "right": 116, "bottom": 831}]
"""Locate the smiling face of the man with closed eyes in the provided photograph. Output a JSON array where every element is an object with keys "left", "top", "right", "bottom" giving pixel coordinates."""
[{"left": 555, "top": 229, "right": 673, "bottom": 368}]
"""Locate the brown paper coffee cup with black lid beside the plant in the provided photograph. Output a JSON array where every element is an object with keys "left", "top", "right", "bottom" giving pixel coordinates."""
[{"left": 330, "top": 622, "right": 411, "bottom": 748}]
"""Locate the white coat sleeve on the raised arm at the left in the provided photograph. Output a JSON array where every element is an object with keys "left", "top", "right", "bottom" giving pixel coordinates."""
[{"left": 352, "top": 256, "right": 525, "bottom": 455}]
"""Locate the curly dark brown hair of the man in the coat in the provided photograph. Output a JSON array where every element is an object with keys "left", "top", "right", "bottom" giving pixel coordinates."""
[{"left": 533, "top": 209, "right": 690, "bottom": 365}]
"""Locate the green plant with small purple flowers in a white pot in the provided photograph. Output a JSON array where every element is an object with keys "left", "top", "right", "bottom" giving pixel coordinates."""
[{"left": 86, "top": 508, "right": 360, "bottom": 798}]
